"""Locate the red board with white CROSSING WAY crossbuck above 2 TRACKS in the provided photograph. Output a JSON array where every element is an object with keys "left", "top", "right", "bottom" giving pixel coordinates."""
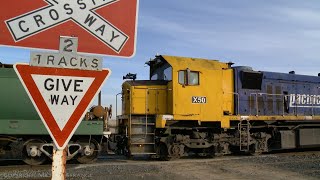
[{"left": 0, "top": 0, "right": 139, "bottom": 57}]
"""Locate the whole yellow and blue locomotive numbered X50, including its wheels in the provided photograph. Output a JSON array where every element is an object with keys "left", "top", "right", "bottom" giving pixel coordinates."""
[{"left": 117, "top": 55, "right": 320, "bottom": 159}]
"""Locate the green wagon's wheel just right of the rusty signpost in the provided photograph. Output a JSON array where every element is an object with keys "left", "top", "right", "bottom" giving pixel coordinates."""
[{"left": 77, "top": 139, "right": 101, "bottom": 164}]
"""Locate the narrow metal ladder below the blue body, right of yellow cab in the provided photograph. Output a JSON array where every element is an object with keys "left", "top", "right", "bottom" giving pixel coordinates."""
[{"left": 238, "top": 120, "right": 250, "bottom": 152}]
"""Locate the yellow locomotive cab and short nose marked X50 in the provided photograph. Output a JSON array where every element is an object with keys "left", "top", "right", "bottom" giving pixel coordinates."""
[{"left": 122, "top": 56, "right": 234, "bottom": 128}]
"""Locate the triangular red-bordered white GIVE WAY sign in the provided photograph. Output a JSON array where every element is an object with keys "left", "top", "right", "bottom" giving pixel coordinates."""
[{"left": 14, "top": 64, "right": 111, "bottom": 149}]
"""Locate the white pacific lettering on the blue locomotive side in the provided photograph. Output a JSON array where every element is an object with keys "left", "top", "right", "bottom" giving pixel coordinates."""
[{"left": 289, "top": 94, "right": 320, "bottom": 108}]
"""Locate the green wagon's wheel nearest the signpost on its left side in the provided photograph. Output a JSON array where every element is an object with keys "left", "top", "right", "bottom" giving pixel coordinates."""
[{"left": 22, "top": 139, "right": 48, "bottom": 165}]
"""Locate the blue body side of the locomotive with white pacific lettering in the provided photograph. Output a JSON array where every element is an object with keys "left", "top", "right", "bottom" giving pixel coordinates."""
[{"left": 234, "top": 67, "right": 320, "bottom": 116}]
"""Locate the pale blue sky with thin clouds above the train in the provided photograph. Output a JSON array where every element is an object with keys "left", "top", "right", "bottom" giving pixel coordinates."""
[{"left": 0, "top": 0, "right": 320, "bottom": 116}]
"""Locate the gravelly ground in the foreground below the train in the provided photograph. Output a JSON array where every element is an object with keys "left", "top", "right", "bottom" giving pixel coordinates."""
[{"left": 0, "top": 151, "right": 320, "bottom": 179}]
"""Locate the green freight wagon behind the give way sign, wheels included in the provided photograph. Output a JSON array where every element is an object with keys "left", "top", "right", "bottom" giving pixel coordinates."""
[{"left": 0, "top": 63, "right": 107, "bottom": 165}]
